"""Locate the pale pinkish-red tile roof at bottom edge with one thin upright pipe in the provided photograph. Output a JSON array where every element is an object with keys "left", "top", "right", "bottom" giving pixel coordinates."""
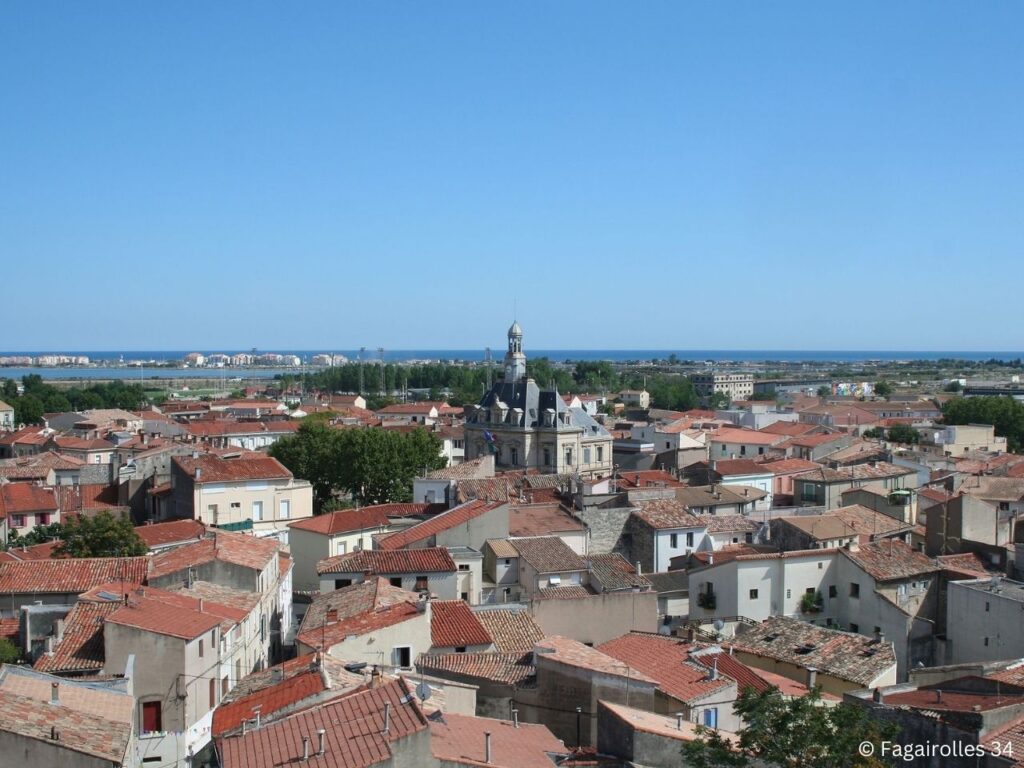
[{"left": 430, "top": 713, "right": 568, "bottom": 768}]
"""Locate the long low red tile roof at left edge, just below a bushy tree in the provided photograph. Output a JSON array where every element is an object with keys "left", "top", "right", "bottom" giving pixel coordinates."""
[{"left": 0, "top": 557, "right": 150, "bottom": 594}]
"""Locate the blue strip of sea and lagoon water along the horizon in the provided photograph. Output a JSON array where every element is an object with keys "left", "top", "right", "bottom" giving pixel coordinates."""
[{"left": 0, "top": 349, "right": 1024, "bottom": 381}]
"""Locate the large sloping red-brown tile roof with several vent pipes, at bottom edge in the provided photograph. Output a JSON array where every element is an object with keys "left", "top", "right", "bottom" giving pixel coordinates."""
[{"left": 217, "top": 678, "right": 427, "bottom": 768}]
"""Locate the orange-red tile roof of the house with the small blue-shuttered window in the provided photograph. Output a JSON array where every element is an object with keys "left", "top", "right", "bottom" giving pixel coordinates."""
[{"left": 597, "top": 632, "right": 733, "bottom": 702}]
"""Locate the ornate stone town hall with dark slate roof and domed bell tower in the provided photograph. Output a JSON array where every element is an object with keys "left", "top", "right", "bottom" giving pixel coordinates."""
[{"left": 465, "top": 323, "right": 612, "bottom": 477}]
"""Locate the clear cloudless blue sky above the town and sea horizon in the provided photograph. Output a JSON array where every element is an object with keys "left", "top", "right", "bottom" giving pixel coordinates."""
[{"left": 0, "top": 0, "right": 1024, "bottom": 352}]
